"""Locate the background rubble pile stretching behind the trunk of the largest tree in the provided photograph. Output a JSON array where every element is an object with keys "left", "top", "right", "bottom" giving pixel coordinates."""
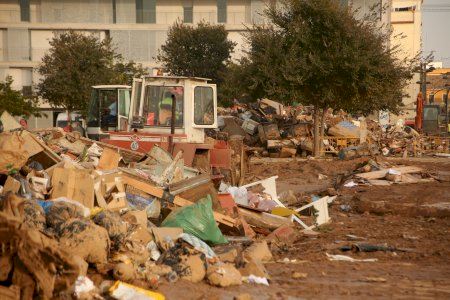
[{"left": 210, "top": 99, "right": 450, "bottom": 159}]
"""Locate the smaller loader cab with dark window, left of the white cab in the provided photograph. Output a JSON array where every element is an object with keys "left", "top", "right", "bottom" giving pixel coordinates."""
[{"left": 87, "top": 85, "right": 131, "bottom": 140}]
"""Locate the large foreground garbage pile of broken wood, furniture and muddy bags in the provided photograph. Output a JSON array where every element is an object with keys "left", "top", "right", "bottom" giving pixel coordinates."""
[{"left": 0, "top": 128, "right": 326, "bottom": 299}]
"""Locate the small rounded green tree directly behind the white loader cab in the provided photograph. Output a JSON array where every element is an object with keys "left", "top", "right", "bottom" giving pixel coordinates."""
[{"left": 157, "top": 22, "right": 236, "bottom": 83}]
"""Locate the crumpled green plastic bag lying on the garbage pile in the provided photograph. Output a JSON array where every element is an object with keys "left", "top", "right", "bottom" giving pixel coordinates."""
[{"left": 161, "top": 195, "right": 228, "bottom": 244}]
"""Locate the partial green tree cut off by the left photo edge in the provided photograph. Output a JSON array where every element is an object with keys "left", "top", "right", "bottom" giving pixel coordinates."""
[{"left": 0, "top": 76, "right": 40, "bottom": 117}]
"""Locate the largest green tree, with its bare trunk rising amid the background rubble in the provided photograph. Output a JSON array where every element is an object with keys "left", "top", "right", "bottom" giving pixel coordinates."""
[{"left": 234, "top": 0, "right": 415, "bottom": 156}]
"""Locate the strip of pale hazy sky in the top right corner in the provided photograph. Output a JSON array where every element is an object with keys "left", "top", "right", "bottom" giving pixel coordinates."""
[{"left": 422, "top": 0, "right": 450, "bottom": 68}]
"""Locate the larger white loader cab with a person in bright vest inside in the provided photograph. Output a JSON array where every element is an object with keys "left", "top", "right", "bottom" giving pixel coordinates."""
[{"left": 129, "top": 76, "right": 217, "bottom": 143}]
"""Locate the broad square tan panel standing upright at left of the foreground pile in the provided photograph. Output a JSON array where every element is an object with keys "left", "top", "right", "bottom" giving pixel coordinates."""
[{"left": 51, "top": 168, "right": 94, "bottom": 208}]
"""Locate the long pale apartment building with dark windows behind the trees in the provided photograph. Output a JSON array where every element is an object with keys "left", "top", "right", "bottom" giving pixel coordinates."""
[{"left": 0, "top": 0, "right": 390, "bottom": 127}]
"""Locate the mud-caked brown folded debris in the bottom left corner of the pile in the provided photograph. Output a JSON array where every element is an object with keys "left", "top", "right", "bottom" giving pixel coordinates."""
[{"left": 0, "top": 212, "right": 87, "bottom": 299}]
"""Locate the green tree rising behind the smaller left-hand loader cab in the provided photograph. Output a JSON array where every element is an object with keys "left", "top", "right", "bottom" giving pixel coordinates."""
[{"left": 37, "top": 31, "right": 144, "bottom": 117}]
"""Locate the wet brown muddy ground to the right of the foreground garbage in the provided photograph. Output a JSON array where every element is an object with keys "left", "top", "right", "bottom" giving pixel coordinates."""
[{"left": 159, "top": 158, "right": 450, "bottom": 299}]
